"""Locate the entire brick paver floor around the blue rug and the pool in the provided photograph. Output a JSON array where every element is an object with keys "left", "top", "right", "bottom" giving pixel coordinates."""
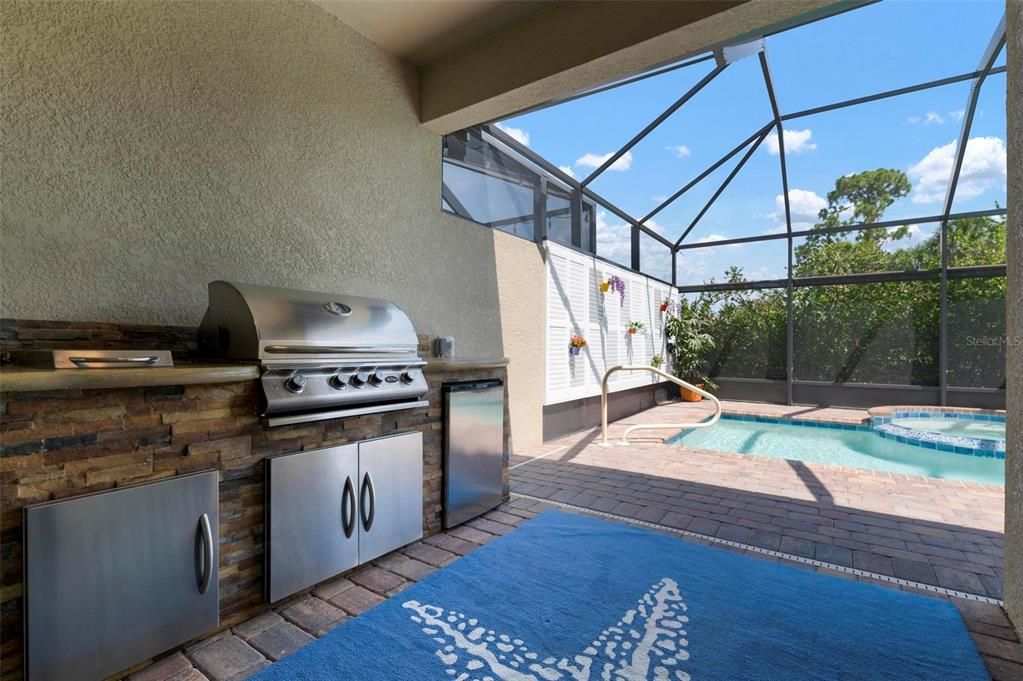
[{"left": 127, "top": 403, "right": 1023, "bottom": 681}]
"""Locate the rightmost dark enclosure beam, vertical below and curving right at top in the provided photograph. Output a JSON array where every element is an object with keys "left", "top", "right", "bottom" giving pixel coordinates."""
[{"left": 938, "top": 14, "right": 1006, "bottom": 406}]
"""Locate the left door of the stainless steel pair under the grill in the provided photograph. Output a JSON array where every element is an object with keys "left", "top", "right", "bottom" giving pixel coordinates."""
[{"left": 265, "top": 445, "right": 359, "bottom": 602}]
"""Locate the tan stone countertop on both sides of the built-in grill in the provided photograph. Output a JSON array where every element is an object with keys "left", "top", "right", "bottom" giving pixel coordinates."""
[{"left": 0, "top": 358, "right": 508, "bottom": 393}]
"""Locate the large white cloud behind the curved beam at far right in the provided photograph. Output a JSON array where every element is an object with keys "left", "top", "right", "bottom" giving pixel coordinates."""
[{"left": 909, "top": 137, "right": 1007, "bottom": 203}]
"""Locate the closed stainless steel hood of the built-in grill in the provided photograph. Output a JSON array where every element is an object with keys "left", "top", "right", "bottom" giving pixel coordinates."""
[{"left": 198, "top": 281, "right": 418, "bottom": 364}]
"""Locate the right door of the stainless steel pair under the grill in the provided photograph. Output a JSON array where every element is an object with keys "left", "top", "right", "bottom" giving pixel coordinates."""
[{"left": 359, "top": 433, "right": 422, "bottom": 562}]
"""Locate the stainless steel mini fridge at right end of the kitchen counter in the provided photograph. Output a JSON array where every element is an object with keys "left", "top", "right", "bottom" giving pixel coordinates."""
[{"left": 443, "top": 378, "right": 504, "bottom": 528}]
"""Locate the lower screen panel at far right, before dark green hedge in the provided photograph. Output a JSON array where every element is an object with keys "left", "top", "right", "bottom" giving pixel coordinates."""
[{"left": 947, "top": 277, "right": 1006, "bottom": 389}]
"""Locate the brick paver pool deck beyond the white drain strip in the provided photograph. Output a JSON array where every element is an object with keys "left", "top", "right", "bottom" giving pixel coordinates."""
[{"left": 512, "top": 402, "right": 1005, "bottom": 599}]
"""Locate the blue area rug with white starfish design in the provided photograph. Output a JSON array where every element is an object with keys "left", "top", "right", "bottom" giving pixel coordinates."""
[{"left": 245, "top": 511, "right": 988, "bottom": 681}]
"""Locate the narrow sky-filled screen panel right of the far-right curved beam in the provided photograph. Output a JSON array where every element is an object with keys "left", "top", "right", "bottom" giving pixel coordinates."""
[{"left": 949, "top": 74, "right": 1008, "bottom": 213}]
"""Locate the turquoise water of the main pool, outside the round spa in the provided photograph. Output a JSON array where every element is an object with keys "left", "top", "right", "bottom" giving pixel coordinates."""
[{"left": 669, "top": 418, "right": 1006, "bottom": 485}]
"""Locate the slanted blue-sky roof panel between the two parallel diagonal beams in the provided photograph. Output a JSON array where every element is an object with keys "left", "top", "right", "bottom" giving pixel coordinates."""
[{"left": 590, "top": 55, "right": 773, "bottom": 222}]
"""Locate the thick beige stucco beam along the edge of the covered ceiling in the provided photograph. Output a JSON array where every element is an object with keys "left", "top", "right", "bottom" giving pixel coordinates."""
[{"left": 419, "top": 0, "right": 869, "bottom": 134}]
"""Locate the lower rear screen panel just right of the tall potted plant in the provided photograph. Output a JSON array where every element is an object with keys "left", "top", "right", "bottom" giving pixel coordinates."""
[{"left": 685, "top": 288, "right": 786, "bottom": 380}]
